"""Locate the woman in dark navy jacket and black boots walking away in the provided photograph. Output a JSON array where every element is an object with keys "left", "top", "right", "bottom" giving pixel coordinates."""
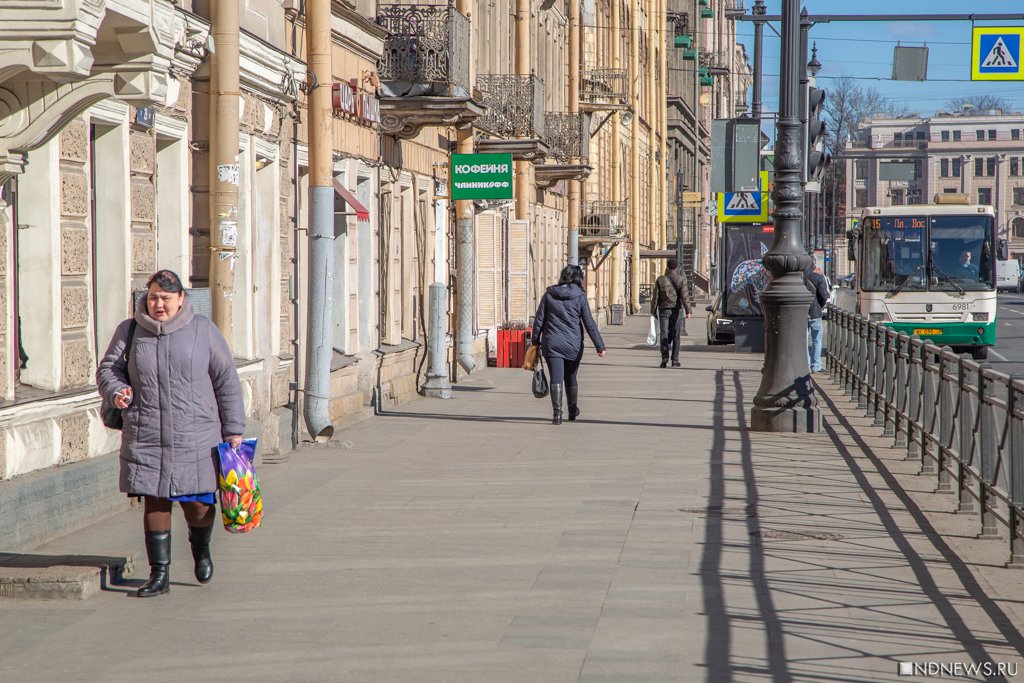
[{"left": 534, "top": 265, "right": 605, "bottom": 425}]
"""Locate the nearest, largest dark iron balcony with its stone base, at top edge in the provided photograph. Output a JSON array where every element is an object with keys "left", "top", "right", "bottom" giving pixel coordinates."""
[{"left": 377, "top": 4, "right": 484, "bottom": 138}]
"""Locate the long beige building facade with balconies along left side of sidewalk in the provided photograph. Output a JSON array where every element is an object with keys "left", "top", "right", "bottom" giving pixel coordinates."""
[{"left": 0, "top": 0, "right": 692, "bottom": 548}]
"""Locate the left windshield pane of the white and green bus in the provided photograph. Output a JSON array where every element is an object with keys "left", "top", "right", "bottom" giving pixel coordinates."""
[{"left": 861, "top": 216, "right": 928, "bottom": 292}]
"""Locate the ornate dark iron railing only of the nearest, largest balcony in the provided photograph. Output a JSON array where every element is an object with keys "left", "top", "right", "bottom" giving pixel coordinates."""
[{"left": 377, "top": 4, "right": 470, "bottom": 97}]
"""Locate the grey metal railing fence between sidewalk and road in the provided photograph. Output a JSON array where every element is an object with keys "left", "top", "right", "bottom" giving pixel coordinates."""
[{"left": 826, "top": 307, "right": 1024, "bottom": 566}]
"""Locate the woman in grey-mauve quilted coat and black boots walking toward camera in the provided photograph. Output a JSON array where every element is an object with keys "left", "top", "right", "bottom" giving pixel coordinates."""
[{"left": 96, "top": 270, "right": 246, "bottom": 597}]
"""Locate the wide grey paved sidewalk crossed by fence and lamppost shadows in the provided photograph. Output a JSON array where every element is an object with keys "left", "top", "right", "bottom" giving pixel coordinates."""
[{"left": 0, "top": 316, "right": 1024, "bottom": 683}]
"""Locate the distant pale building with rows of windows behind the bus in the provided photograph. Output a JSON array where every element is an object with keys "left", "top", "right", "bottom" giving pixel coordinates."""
[{"left": 845, "top": 108, "right": 1024, "bottom": 258}]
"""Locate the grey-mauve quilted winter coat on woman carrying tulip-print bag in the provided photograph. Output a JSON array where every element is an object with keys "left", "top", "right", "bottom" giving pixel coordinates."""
[{"left": 96, "top": 297, "right": 246, "bottom": 498}]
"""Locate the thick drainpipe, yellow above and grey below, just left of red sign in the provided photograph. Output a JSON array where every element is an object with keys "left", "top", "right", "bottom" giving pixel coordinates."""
[{"left": 302, "top": 0, "right": 334, "bottom": 443}]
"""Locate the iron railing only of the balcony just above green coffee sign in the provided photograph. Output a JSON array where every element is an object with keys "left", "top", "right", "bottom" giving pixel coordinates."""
[{"left": 476, "top": 74, "right": 545, "bottom": 138}]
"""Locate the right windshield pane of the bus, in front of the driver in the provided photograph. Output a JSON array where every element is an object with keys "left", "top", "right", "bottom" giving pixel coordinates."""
[{"left": 931, "top": 214, "right": 995, "bottom": 291}]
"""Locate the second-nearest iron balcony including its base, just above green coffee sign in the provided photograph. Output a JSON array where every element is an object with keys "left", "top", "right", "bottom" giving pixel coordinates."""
[{"left": 475, "top": 74, "right": 548, "bottom": 161}]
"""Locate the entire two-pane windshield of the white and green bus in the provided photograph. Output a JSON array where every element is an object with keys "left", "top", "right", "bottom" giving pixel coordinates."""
[{"left": 861, "top": 214, "right": 995, "bottom": 293}]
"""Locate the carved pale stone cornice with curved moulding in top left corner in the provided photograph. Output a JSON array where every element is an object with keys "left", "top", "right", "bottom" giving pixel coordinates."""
[{"left": 0, "top": 0, "right": 176, "bottom": 178}]
